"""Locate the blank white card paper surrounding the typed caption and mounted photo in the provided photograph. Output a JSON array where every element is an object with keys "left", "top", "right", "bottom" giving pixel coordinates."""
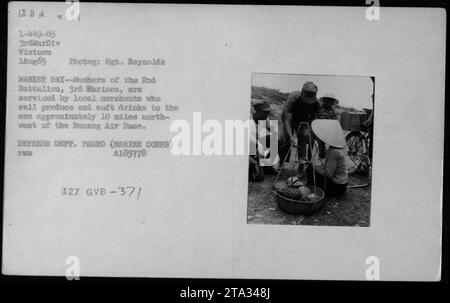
[{"left": 3, "top": 2, "right": 446, "bottom": 280}]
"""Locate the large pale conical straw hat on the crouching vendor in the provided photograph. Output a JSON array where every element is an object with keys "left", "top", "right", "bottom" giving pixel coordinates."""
[{"left": 311, "top": 119, "right": 346, "bottom": 148}]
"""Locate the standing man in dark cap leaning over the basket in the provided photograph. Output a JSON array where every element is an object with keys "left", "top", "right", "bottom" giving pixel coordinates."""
[{"left": 279, "top": 81, "right": 320, "bottom": 164}]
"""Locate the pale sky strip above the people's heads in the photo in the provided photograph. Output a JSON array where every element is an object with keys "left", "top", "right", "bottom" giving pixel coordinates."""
[{"left": 252, "top": 73, "right": 376, "bottom": 109}]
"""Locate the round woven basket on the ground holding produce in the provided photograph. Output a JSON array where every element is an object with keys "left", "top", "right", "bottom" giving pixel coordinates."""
[{"left": 274, "top": 185, "right": 325, "bottom": 215}]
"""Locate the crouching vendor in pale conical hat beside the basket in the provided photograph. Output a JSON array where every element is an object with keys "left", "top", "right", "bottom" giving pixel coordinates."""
[{"left": 307, "top": 119, "right": 348, "bottom": 197}]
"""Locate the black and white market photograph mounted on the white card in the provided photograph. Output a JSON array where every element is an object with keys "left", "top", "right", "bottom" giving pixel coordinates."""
[{"left": 247, "top": 73, "right": 375, "bottom": 227}]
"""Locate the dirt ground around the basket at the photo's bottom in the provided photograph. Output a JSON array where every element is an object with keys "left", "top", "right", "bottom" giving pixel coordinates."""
[{"left": 247, "top": 175, "right": 371, "bottom": 226}]
